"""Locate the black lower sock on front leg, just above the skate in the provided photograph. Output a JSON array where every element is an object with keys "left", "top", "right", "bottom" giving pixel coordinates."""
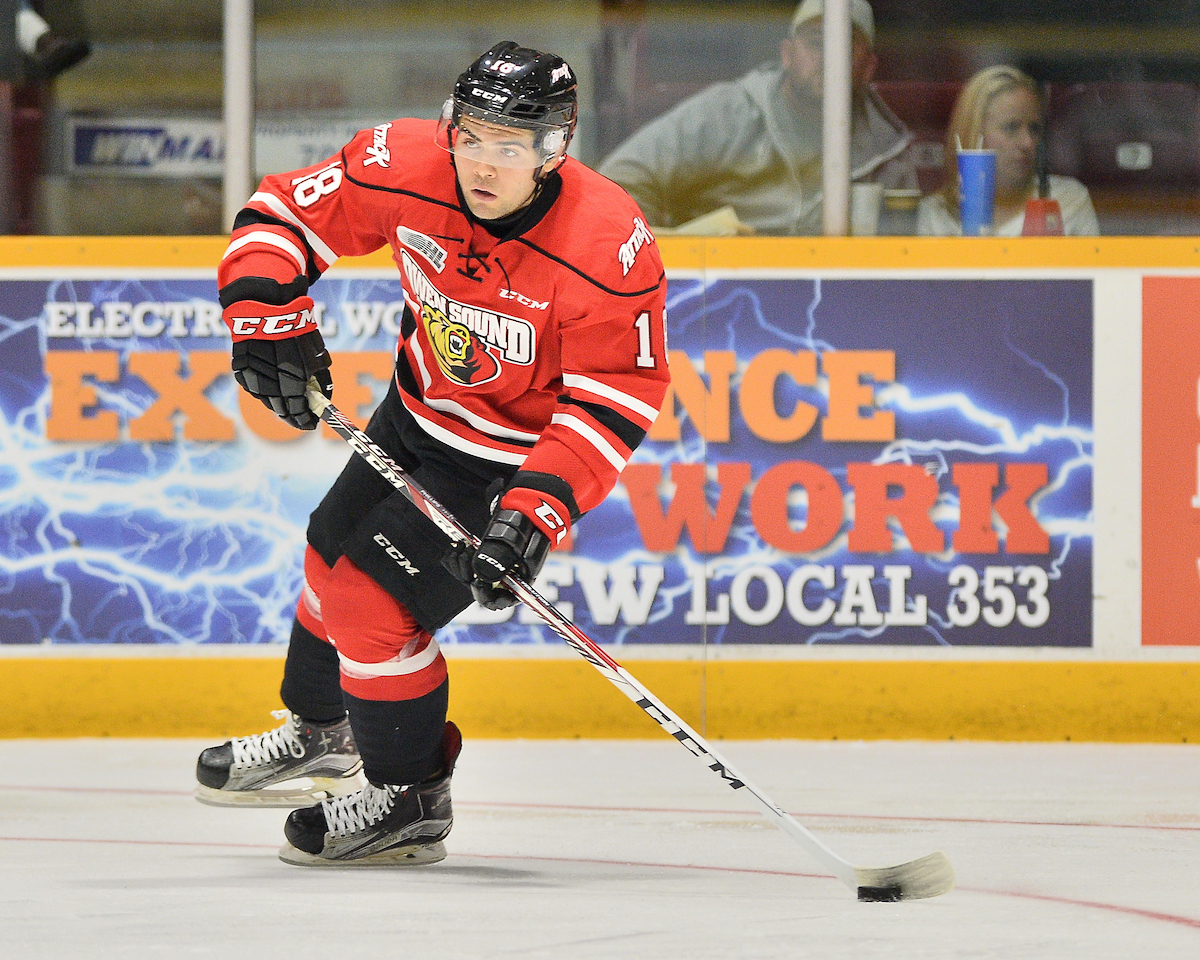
[{"left": 346, "top": 680, "right": 450, "bottom": 785}]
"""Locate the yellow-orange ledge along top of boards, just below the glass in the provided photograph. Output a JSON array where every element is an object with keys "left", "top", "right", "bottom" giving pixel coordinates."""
[{"left": 7, "top": 236, "right": 1200, "bottom": 270}]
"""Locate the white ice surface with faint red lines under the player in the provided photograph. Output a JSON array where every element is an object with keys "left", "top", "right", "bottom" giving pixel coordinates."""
[{"left": 0, "top": 739, "right": 1200, "bottom": 960}]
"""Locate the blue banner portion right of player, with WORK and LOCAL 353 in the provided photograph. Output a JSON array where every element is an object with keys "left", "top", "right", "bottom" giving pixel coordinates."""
[{"left": 595, "top": 277, "right": 1093, "bottom": 647}]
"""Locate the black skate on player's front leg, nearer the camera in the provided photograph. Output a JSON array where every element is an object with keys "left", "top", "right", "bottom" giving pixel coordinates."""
[{"left": 280, "top": 722, "right": 462, "bottom": 866}]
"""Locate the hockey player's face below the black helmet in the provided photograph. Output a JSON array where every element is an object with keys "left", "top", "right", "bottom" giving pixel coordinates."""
[{"left": 454, "top": 116, "right": 539, "bottom": 220}]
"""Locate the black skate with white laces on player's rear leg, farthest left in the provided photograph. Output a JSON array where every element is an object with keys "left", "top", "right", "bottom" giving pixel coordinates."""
[{"left": 189, "top": 710, "right": 366, "bottom": 806}]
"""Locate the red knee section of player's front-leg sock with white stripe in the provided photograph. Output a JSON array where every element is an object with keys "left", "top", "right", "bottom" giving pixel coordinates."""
[{"left": 322, "top": 557, "right": 446, "bottom": 700}]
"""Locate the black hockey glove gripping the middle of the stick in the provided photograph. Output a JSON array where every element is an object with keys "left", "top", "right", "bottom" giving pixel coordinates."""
[{"left": 442, "top": 508, "right": 550, "bottom": 610}]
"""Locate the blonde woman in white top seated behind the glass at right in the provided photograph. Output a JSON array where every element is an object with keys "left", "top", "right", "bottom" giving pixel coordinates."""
[{"left": 917, "top": 66, "right": 1100, "bottom": 236}]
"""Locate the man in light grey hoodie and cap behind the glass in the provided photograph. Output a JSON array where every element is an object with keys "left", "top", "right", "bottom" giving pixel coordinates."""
[{"left": 599, "top": 0, "right": 917, "bottom": 235}]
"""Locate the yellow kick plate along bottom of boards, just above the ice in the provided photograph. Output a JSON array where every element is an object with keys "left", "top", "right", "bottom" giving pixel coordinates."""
[{"left": 0, "top": 656, "right": 1200, "bottom": 743}]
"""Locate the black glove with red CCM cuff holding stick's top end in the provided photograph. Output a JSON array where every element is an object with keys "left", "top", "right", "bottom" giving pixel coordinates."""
[{"left": 224, "top": 296, "right": 334, "bottom": 430}]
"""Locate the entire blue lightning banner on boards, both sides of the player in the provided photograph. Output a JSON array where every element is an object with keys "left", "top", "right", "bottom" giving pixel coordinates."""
[{"left": 0, "top": 271, "right": 1093, "bottom": 647}]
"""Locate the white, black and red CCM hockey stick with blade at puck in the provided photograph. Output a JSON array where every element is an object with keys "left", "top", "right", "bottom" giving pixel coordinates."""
[{"left": 307, "top": 379, "right": 954, "bottom": 901}]
